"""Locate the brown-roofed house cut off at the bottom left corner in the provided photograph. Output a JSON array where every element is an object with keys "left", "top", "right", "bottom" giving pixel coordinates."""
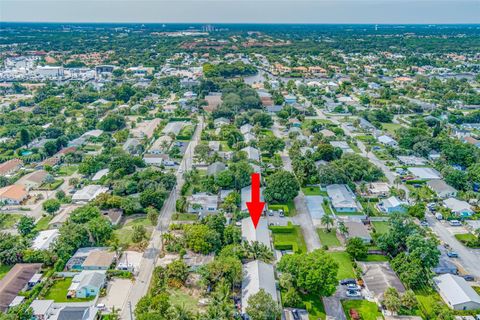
[{"left": 0, "top": 263, "right": 42, "bottom": 312}]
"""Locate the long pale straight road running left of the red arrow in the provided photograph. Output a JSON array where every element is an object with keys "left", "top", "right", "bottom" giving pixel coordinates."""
[{"left": 121, "top": 119, "right": 203, "bottom": 320}]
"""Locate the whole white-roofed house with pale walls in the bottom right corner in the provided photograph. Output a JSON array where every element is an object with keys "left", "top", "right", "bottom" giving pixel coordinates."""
[{"left": 433, "top": 273, "right": 480, "bottom": 310}]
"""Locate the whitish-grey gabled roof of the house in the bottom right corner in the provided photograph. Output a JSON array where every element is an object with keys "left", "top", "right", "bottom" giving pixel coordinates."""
[{"left": 433, "top": 273, "right": 480, "bottom": 306}]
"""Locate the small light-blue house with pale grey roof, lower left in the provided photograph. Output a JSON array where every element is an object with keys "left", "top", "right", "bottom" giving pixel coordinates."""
[{"left": 67, "top": 270, "right": 107, "bottom": 298}]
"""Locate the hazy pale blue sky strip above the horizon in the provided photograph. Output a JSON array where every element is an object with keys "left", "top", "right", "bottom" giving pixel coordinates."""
[{"left": 0, "top": 0, "right": 480, "bottom": 24}]
